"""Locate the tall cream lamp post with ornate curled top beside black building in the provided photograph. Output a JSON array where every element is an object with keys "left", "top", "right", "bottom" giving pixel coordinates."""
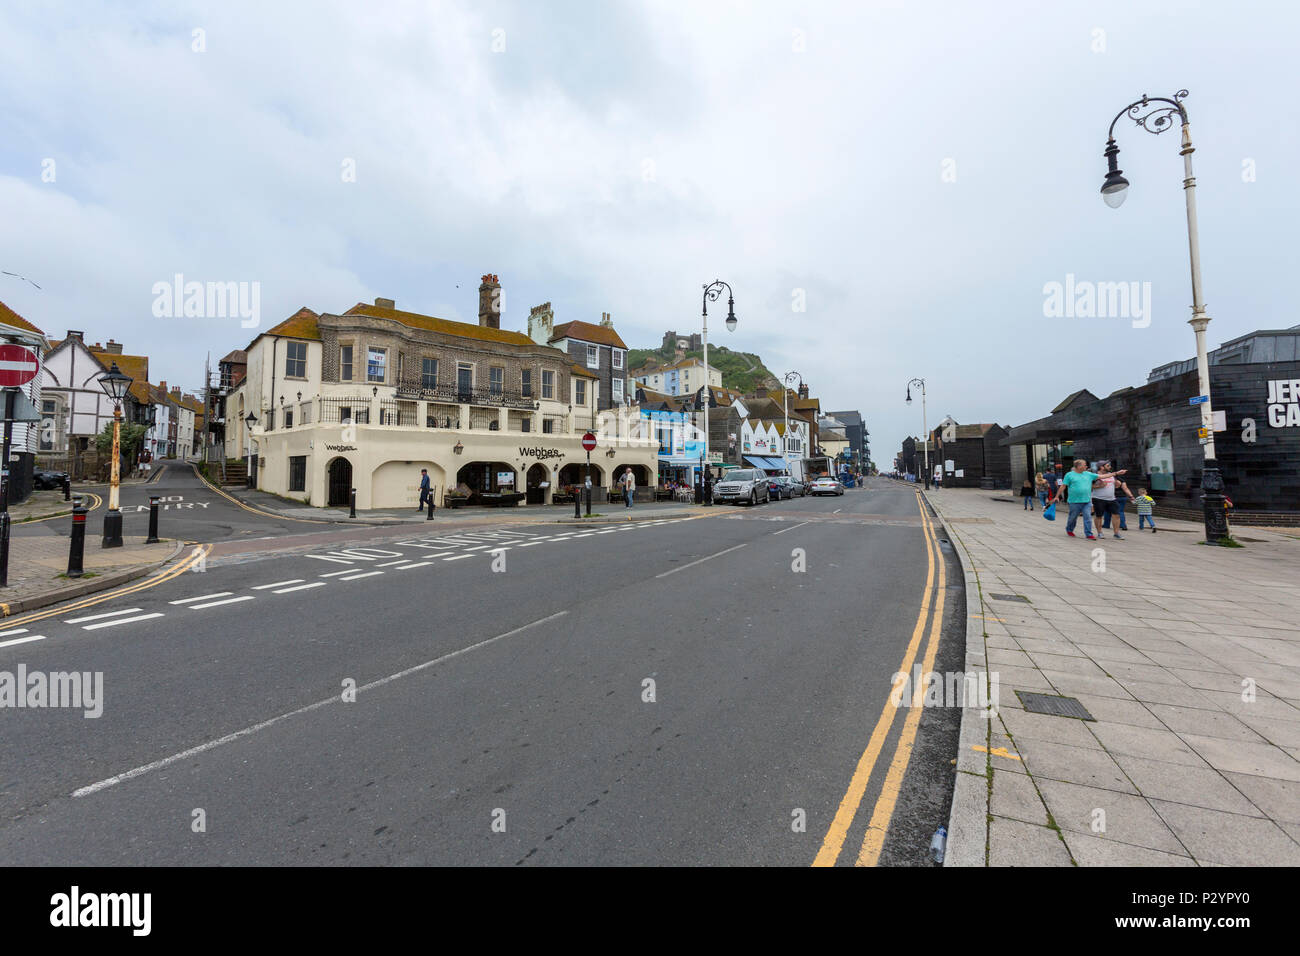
[{"left": 1101, "top": 90, "right": 1229, "bottom": 544}]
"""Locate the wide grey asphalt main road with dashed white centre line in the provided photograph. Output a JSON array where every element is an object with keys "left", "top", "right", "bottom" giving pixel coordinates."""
[{"left": 0, "top": 477, "right": 965, "bottom": 866}]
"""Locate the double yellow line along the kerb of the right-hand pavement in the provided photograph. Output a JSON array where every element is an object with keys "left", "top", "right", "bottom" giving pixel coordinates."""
[{"left": 813, "top": 493, "right": 946, "bottom": 866}]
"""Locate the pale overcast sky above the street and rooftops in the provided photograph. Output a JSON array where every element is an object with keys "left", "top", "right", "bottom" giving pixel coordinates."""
[{"left": 0, "top": 0, "right": 1300, "bottom": 467}]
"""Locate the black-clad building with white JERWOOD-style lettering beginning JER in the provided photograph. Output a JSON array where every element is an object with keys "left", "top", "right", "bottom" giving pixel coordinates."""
[{"left": 1005, "top": 325, "right": 1300, "bottom": 524}]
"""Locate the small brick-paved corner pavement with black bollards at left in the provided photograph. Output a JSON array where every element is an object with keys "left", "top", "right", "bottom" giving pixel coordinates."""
[{"left": 0, "top": 535, "right": 181, "bottom": 616}]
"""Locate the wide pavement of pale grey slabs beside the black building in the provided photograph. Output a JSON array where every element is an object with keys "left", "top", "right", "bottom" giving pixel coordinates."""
[{"left": 927, "top": 489, "right": 1300, "bottom": 866}]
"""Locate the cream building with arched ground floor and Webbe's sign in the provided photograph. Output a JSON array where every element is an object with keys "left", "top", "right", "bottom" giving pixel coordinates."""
[{"left": 225, "top": 274, "right": 658, "bottom": 509}]
